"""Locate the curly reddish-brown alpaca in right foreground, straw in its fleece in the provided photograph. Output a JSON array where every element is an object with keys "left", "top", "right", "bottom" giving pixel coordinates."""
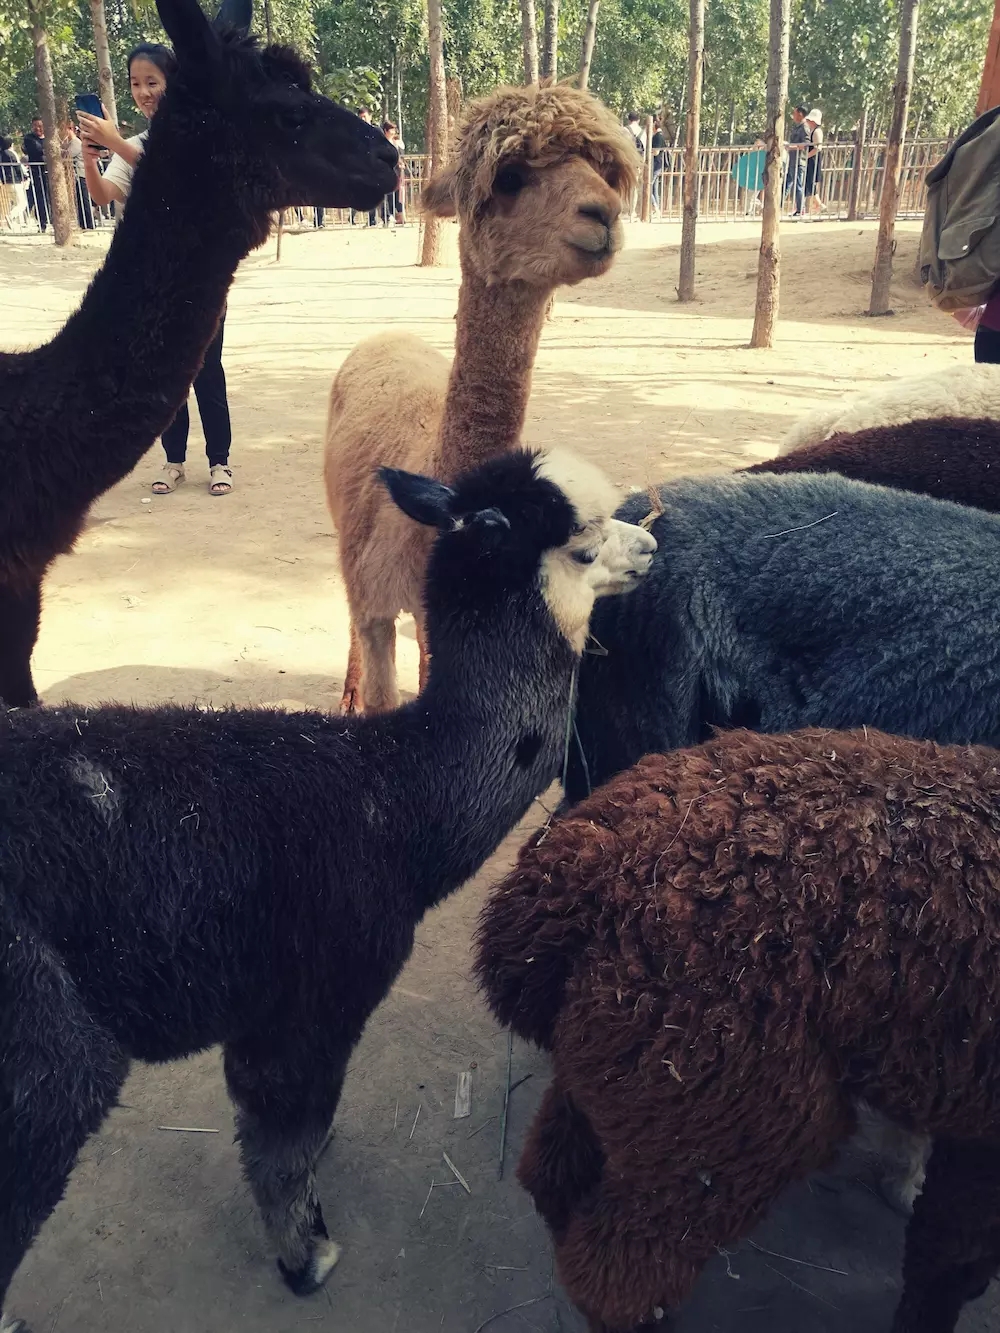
[{"left": 477, "top": 730, "right": 1000, "bottom": 1333}]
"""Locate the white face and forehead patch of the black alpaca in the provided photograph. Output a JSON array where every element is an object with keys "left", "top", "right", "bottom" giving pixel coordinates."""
[{"left": 536, "top": 449, "right": 656, "bottom": 653}]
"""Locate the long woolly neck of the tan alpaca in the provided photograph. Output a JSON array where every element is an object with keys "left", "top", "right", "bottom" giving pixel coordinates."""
[{"left": 439, "top": 241, "right": 552, "bottom": 480}]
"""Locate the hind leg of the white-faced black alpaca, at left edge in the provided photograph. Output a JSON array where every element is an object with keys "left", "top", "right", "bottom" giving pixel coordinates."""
[{"left": 0, "top": 926, "right": 128, "bottom": 1333}]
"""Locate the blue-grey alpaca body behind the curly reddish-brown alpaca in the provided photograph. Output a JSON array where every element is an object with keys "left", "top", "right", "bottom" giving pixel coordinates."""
[{"left": 567, "top": 473, "right": 1000, "bottom": 801}]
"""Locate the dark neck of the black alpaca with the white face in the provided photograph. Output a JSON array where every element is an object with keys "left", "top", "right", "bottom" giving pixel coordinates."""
[{"left": 372, "top": 595, "right": 576, "bottom": 917}]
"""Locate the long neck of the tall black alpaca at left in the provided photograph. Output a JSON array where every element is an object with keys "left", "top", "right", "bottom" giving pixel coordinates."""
[{"left": 15, "top": 102, "right": 263, "bottom": 504}]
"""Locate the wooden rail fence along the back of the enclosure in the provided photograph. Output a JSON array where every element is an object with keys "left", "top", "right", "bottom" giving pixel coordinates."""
[{"left": 0, "top": 139, "right": 948, "bottom": 237}]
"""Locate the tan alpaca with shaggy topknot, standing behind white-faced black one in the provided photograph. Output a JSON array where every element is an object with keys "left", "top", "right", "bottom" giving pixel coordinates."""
[{"left": 324, "top": 85, "right": 639, "bottom": 712}]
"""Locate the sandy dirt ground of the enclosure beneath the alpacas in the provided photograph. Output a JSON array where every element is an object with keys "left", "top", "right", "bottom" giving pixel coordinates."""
[{"left": 0, "top": 223, "right": 1000, "bottom": 1333}]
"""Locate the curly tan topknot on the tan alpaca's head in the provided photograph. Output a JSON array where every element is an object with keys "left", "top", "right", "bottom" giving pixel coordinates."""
[{"left": 453, "top": 84, "right": 640, "bottom": 217}]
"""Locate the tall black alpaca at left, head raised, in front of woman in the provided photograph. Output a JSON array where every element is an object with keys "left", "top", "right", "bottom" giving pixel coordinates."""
[{"left": 0, "top": 0, "right": 396, "bottom": 706}]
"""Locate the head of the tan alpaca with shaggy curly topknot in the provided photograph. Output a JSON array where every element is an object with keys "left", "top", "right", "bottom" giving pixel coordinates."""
[{"left": 423, "top": 84, "right": 639, "bottom": 288}]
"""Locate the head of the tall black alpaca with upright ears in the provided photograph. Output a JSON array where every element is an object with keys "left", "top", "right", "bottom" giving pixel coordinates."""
[{"left": 153, "top": 0, "right": 396, "bottom": 217}]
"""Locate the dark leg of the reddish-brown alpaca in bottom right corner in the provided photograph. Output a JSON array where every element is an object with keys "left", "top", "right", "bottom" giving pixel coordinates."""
[{"left": 892, "top": 1138, "right": 1000, "bottom": 1333}]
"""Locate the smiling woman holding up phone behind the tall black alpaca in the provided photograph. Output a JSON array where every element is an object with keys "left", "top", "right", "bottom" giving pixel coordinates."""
[{"left": 77, "top": 41, "right": 232, "bottom": 496}]
